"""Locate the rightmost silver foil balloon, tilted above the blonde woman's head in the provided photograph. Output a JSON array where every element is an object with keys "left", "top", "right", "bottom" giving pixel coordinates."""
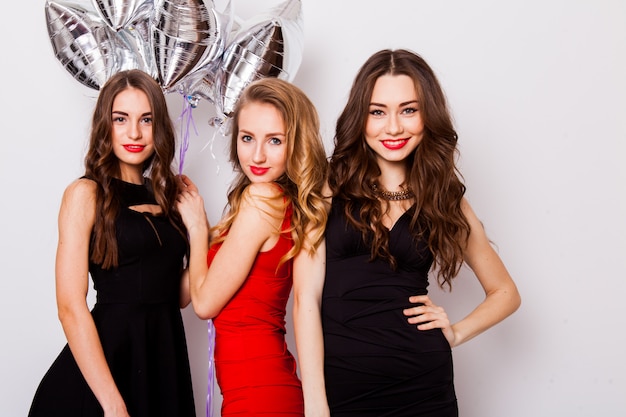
[{"left": 215, "top": 0, "right": 303, "bottom": 118}]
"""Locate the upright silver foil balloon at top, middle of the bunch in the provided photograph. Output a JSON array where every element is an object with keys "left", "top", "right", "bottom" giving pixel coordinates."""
[{"left": 151, "top": 0, "right": 223, "bottom": 91}]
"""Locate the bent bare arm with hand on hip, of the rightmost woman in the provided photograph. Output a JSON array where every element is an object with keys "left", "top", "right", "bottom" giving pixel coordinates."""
[{"left": 404, "top": 199, "right": 521, "bottom": 347}]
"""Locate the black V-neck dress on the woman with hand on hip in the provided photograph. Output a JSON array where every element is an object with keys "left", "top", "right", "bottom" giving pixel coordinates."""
[{"left": 322, "top": 199, "right": 458, "bottom": 417}]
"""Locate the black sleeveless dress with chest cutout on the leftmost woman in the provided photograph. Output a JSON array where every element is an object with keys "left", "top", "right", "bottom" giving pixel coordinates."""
[{"left": 29, "top": 180, "right": 195, "bottom": 417}]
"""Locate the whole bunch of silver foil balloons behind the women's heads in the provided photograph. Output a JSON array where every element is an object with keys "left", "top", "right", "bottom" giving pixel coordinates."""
[{"left": 46, "top": 0, "right": 303, "bottom": 140}]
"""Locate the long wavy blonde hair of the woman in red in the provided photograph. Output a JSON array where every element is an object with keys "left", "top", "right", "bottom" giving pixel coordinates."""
[{"left": 212, "top": 77, "right": 328, "bottom": 263}]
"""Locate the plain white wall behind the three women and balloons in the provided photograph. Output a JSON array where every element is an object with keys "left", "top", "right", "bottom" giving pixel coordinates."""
[{"left": 0, "top": 0, "right": 626, "bottom": 417}]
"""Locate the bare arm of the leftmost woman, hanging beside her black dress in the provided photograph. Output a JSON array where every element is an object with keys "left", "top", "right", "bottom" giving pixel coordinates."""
[{"left": 55, "top": 179, "right": 129, "bottom": 417}]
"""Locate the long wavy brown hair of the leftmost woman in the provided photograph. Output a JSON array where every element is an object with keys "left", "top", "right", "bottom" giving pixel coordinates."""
[{"left": 85, "top": 70, "right": 186, "bottom": 269}]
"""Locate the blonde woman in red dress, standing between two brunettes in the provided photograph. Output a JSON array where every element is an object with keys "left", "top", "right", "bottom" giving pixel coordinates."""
[{"left": 178, "top": 78, "right": 328, "bottom": 417}]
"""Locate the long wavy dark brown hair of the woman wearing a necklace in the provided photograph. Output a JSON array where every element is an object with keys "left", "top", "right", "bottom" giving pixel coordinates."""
[{"left": 329, "top": 49, "right": 470, "bottom": 288}]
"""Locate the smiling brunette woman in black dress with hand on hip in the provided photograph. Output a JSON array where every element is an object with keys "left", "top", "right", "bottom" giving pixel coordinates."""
[{"left": 322, "top": 50, "right": 520, "bottom": 417}]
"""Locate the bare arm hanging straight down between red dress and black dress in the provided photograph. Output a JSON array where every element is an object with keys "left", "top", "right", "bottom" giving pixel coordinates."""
[{"left": 293, "top": 236, "right": 330, "bottom": 417}]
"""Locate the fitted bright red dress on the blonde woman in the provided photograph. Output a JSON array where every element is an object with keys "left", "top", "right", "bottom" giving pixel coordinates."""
[{"left": 207, "top": 205, "right": 304, "bottom": 417}]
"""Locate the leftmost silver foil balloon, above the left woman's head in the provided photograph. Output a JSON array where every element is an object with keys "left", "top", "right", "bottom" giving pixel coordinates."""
[{"left": 45, "top": 1, "right": 116, "bottom": 90}]
